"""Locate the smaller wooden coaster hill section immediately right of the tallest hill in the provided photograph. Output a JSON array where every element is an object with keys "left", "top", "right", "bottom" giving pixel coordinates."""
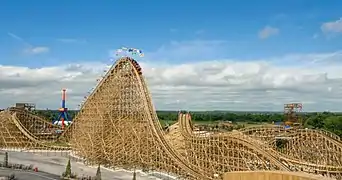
[{"left": 179, "top": 114, "right": 289, "bottom": 177}]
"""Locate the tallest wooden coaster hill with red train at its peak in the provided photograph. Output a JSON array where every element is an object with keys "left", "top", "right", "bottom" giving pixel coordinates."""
[{"left": 70, "top": 58, "right": 208, "bottom": 179}]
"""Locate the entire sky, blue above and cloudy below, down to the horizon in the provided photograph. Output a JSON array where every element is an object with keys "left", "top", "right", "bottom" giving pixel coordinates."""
[{"left": 0, "top": 0, "right": 342, "bottom": 111}]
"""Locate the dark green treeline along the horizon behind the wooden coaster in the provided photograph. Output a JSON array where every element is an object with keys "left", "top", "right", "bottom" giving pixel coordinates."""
[{"left": 35, "top": 110, "right": 342, "bottom": 137}]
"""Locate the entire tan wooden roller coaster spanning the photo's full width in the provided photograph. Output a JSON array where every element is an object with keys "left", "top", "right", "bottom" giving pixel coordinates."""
[{"left": 0, "top": 57, "right": 342, "bottom": 180}]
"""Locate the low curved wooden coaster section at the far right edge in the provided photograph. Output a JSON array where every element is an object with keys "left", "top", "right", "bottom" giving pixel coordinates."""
[{"left": 240, "top": 126, "right": 342, "bottom": 178}]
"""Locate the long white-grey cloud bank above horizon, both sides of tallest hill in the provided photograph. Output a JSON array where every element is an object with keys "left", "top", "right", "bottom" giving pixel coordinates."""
[{"left": 0, "top": 41, "right": 342, "bottom": 111}]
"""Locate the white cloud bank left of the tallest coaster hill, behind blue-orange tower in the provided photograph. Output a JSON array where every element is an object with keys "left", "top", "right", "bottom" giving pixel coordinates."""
[{"left": 0, "top": 63, "right": 105, "bottom": 108}]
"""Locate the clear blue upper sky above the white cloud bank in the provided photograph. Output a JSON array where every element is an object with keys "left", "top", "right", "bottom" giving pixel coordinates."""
[{"left": 0, "top": 0, "right": 342, "bottom": 67}]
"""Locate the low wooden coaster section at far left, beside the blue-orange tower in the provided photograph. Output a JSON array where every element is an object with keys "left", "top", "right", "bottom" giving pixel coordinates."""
[{"left": 0, "top": 109, "right": 70, "bottom": 150}]
